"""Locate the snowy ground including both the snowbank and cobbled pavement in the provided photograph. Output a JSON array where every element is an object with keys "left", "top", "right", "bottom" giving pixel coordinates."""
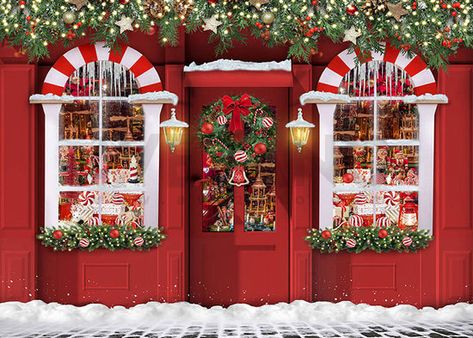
[{"left": 0, "top": 301, "right": 473, "bottom": 338}]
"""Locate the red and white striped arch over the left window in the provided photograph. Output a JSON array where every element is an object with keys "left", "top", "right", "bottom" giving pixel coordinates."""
[{"left": 42, "top": 42, "right": 163, "bottom": 95}]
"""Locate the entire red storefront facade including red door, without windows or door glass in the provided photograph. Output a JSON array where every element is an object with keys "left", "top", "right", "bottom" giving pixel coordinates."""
[{"left": 0, "top": 34, "right": 473, "bottom": 307}]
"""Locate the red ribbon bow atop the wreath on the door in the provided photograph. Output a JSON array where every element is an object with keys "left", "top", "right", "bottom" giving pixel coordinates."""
[{"left": 222, "top": 94, "right": 253, "bottom": 141}]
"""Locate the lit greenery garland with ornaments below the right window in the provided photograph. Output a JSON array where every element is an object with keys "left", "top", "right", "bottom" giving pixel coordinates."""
[{"left": 305, "top": 226, "right": 433, "bottom": 253}]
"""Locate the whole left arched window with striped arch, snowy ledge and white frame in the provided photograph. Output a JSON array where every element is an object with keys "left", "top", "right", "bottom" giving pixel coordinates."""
[{"left": 30, "top": 43, "right": 177, "bottom": 230}]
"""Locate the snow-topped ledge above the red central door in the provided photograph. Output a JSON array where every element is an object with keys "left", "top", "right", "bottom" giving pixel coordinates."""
[{"left": 184, "top": 59, "right": 292, "bottom": 73}]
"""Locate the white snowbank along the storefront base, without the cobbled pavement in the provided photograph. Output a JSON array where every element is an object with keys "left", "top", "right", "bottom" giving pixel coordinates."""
[{"left": 0, "top": 300, "right": 473, "bottom": 327}]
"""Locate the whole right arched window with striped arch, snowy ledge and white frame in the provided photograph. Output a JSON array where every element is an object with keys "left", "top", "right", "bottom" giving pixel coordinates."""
[{"left": 301, "top": 46, "right": 447, "bottom": 235}]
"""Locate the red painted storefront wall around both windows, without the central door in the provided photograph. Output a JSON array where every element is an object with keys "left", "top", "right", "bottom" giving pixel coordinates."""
[{"left": 0, "top": 33, "right": 473, "bottom": 306}]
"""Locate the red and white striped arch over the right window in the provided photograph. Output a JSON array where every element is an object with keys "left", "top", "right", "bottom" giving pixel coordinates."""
[{"left": 317, "top": 44, "right": 437, "bottom": 95}]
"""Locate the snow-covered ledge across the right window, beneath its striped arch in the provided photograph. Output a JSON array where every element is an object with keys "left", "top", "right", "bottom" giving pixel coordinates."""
[{"left": 299, "top": 90, "right": 448, "bottom": 105}]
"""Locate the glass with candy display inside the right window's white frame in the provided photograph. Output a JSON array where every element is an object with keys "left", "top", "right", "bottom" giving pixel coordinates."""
[{"left": 332, "top": 61, "right": 422, "bottom": 230}]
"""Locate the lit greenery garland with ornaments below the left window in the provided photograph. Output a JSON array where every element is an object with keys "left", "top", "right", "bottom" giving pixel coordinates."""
[{"left": 37, "top": 222, "right": 166, "bottom": 251}]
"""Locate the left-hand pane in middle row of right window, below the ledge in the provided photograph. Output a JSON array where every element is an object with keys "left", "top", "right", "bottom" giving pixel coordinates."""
[{"left": 333, "top": 147, "right": 373, "bottom": 187}]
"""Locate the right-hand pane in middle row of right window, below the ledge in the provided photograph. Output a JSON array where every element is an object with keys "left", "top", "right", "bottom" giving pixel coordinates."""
[{"left": 376, "top": 146, "right": 419, "bottom": 186}]
